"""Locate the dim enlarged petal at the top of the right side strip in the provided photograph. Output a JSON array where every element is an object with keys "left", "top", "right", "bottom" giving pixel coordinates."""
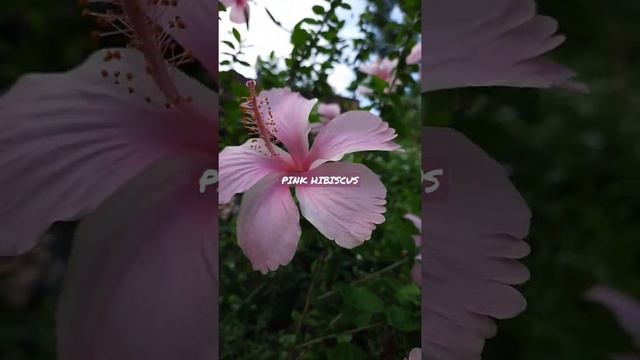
[{"left": 422, "top": 0, "right": 587, "bottom": 91}]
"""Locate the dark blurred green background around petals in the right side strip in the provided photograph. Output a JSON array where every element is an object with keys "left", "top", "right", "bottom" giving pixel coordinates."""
[{"left": 423, "top": 0, "right": 640, "bottom": 360}]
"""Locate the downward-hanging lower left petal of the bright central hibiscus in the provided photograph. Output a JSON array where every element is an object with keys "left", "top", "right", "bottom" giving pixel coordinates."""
[{"left": 237, "top": 174, "right": 301, "bottom": 274}]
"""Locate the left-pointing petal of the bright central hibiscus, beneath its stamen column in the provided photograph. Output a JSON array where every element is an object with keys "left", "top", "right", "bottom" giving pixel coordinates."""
[{"left": 218, "top": 139, "right": 293, "bottom": 204}]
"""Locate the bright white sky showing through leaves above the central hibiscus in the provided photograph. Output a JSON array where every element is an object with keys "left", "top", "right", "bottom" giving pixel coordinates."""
[{"left": 219, "top": 0, "right": 402, "bottom": 96}]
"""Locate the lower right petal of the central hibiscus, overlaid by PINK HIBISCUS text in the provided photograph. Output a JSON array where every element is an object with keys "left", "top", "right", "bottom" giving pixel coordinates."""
[{"left": 296, "top": 162, "right": 387, "bottom": 249}]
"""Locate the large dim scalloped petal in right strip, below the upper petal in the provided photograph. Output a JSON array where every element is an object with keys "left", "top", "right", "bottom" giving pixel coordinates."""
[{"left": 422, "top": 127, "right": 531, "bottom": 359}]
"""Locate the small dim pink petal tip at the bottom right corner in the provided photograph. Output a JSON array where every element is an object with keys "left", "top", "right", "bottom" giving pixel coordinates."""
[{"left": 585, "top": 286, "right": 640, "bottom": 347}]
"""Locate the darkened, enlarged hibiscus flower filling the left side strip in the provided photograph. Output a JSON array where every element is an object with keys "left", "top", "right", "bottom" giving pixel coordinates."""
[{"left": 0, "top": 0, "right": 217, "bottom": 360}]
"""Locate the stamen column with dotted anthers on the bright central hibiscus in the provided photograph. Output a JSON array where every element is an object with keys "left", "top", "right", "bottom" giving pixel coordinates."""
[{"left": 240, "top": 80, "right": 278, "bottom": 159}]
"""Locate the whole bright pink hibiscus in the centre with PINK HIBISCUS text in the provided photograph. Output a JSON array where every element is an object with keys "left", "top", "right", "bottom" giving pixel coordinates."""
[{"left": 219, "top": 81, "right": 399, "bottom": 273}]
